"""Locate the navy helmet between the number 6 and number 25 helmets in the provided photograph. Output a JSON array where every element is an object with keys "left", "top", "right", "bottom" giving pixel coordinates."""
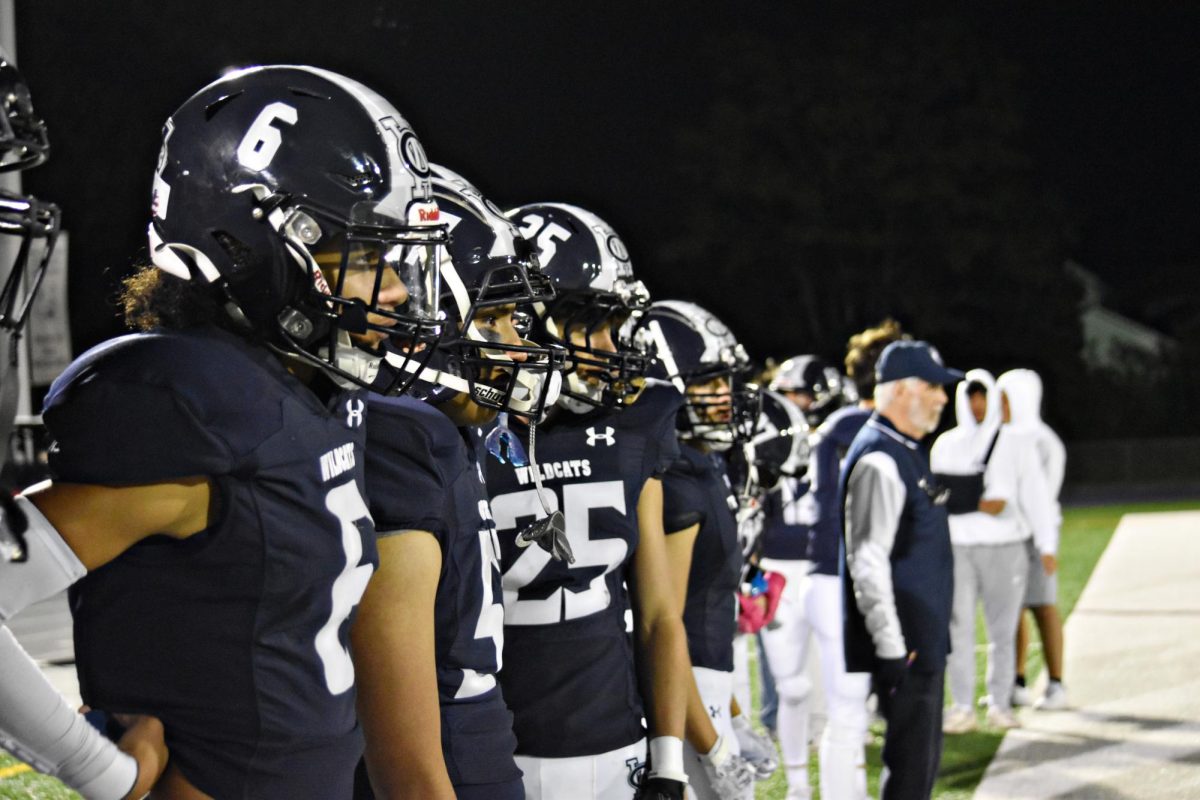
[{"left": 388, "top": 164, "right": 565, "bottom": 420}]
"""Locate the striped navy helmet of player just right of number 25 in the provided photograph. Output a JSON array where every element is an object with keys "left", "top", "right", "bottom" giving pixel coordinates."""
[{"left": 638, "top": 300, "right": 761, "bottom": 450}]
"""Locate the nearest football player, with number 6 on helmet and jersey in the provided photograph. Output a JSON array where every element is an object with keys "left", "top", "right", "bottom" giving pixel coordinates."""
[{"left": 0, "top": 66, "right": 445, "bottom": 800}]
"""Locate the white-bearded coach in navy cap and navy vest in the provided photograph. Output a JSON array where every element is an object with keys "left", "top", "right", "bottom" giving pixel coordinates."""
[{"left": 840, "top": 341, "right": 962, "bottom": 800}]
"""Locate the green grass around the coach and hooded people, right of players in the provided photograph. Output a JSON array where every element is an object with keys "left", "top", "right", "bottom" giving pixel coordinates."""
[{"left": 751, "top": 501, "right": 1200, "bottom": 800}]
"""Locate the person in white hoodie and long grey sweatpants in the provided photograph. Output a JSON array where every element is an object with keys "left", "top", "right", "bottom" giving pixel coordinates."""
[{"left": 930, "top": 369, "right": 1056, "bottom": 734}]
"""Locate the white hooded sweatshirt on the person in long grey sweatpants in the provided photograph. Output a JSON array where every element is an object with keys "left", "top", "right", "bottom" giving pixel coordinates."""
[{"left": 930, "top": 369, "right": 1057, "bottom": 553}]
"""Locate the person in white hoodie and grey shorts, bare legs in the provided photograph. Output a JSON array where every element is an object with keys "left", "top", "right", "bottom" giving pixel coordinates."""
[{"left": 996, "top": 369, "right": 1067, "bottom": 710}]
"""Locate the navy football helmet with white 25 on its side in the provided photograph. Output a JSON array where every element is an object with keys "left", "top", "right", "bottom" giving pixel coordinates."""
[{"left": 508, "top": 203, "right": 653, "bottom": 414}]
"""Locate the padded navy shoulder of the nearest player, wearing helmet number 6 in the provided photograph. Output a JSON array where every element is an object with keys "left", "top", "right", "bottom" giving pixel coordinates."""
[{"left": 42, "top": 330, "right": 290, "bottom": 485}]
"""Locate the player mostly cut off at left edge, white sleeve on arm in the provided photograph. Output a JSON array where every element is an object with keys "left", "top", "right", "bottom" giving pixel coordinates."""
[{"left": 0, "top": 50, "right": 167, "bottom": 800}]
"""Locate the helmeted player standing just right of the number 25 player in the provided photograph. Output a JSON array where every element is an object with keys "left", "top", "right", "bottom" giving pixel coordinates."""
[{"left": 642, "top": 300, "right": 758, "bottom": 800}]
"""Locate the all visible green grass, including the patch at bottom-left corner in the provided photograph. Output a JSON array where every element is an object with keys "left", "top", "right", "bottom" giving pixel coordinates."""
[{"left": 0, "top": 501, "right": 1200, "bottom": 800}]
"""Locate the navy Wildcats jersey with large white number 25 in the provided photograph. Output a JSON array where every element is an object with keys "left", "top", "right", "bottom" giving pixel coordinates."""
[{"left": 485, "top": 385, "right": 683, "bottom": 758}]
